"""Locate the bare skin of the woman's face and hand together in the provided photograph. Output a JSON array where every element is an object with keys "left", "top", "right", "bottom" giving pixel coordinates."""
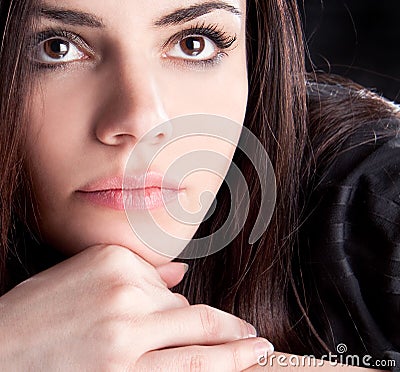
[{"left": 0, "top": 0, "right": 384, "bottom": 371}]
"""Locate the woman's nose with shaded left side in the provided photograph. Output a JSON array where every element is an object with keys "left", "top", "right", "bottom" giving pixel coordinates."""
[{"left": 95, "top": 64, "right": 172, "bottom": 146}]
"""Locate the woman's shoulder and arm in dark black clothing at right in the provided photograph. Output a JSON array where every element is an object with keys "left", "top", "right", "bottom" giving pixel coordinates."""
[{"left": 300, "top": 77, "right": 400, "bottom": 366}]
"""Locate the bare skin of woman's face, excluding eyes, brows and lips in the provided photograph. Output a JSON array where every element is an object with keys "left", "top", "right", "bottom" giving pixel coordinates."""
[{"left": 27, "top": 0, "right": 247, "bottom": 266}]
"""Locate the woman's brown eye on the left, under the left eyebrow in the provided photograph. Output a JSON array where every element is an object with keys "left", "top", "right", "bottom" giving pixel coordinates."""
[{"left": 33, "top": 37, "right": 87, "bottom": 63}]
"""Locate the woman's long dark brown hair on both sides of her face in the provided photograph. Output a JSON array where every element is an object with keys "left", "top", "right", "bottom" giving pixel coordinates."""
[{"left": 0, "top": 0, "right": 398, "bottom": 352}]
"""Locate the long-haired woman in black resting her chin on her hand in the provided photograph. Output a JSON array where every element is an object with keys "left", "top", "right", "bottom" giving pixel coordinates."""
[{"left": 0, "top": 0, "right": 398, "bottom": 371}]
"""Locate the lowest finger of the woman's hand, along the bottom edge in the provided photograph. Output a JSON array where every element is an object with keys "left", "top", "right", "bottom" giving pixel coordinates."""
[{"left": 134, "top": 338, "right": 274, "bottom": 372}]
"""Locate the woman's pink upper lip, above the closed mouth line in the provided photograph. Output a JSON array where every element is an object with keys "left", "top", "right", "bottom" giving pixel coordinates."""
[{"left": 78, "top": 172, "right": 181, "bottom": 192}]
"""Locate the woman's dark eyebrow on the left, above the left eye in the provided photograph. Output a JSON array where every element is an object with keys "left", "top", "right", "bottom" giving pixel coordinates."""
[{"left": 38, "top": 6, "right": 105, "bottom": 28}]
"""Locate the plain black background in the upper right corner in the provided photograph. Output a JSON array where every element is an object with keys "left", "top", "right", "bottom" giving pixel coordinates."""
[{"left": 298, "top": 0, "right": 400, "bottom": 102}]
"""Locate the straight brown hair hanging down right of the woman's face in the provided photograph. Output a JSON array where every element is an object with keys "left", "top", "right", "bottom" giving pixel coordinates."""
[{"left": 179, "top": 0, "right": 308, "bottom": 350}]
